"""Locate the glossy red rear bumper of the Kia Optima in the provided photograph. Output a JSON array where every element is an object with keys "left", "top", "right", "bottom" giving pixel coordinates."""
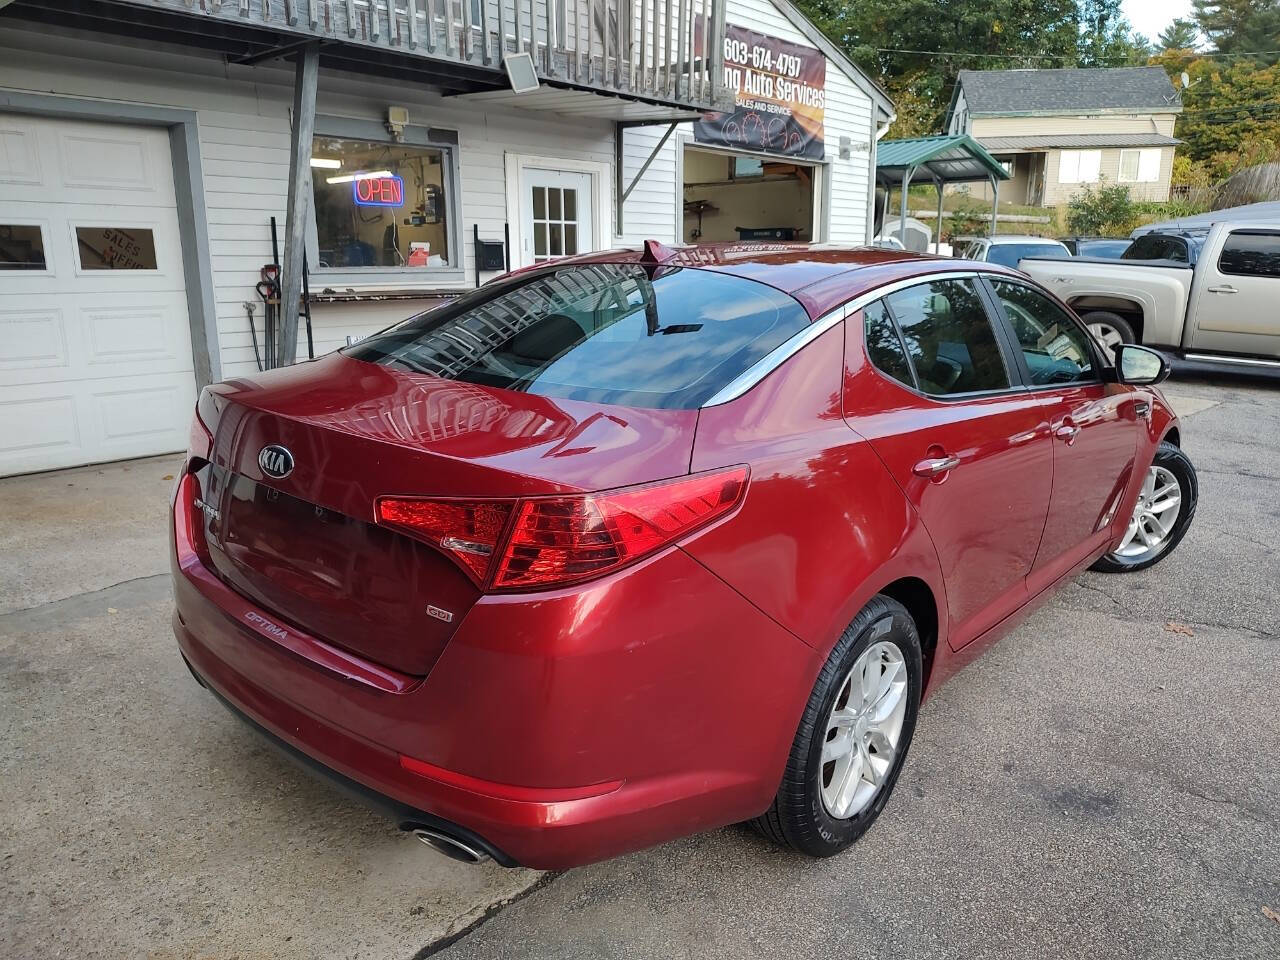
[{"left": 174, "top": 478, "right": 820, "bottom": 869}]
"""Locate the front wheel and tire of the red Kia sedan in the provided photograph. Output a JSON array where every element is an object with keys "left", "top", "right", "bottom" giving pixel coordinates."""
[{"left": 1089, "top": 442, "right": 1199, "bottom": 573}]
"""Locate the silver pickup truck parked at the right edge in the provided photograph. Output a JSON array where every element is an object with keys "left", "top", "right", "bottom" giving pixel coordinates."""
[{"left": 1019, "top": 220, "right": 1280, "bottom": 372}]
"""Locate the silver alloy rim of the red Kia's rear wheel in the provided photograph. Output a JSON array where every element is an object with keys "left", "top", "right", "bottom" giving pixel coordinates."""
[{"left": 822, "top": 640, "right": 908, "bottom": 820}]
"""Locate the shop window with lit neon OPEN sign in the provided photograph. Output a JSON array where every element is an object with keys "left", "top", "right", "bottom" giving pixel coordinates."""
[{"left": 311, "top": 137, "right": 457, "bottom": 270}]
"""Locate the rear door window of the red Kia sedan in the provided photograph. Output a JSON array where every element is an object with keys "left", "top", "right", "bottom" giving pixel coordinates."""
[{"left": 886, "top": 280, "right": 1010, "bottom": 397}]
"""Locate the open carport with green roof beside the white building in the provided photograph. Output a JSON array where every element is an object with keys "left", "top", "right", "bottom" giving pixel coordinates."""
[{"left": 876, "top": 133, "right": 1011, "bottom": 252}]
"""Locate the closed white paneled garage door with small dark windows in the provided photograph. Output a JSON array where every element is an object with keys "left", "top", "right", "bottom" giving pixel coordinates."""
[{"left": 0, "top": 114, "right": 196, "bottom": 476}]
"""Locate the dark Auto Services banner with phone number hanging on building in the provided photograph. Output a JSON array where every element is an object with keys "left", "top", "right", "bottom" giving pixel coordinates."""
[{"left": 694, "top": 24, "right": 827, "bottom": 160}]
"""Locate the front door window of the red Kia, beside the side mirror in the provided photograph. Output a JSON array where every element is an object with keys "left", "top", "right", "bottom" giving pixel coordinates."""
[{"left": 991, "top": 279, "right": 1098, "bottom": 387}]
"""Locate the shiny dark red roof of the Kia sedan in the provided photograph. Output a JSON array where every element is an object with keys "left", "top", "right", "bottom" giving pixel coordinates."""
[{"left": 545, "top": 241, "right": 1020, "bottom": 317}]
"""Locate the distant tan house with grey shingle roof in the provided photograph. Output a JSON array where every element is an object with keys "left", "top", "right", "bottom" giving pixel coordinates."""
[{"left": 946, "top": 67, "right": 1183, "bottom": 206}]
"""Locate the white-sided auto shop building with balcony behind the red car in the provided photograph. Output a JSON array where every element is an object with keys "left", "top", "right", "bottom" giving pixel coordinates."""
[{"left": 0, "top": 0, "right": 892, "bottom": 475}]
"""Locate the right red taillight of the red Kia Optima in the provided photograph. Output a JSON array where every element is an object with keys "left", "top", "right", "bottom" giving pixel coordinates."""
[{"left": 378, "top": 467, "right": 748, "bottom": 590}]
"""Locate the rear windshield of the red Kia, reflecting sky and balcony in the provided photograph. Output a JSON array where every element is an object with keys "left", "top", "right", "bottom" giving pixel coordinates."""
[{"left": 344, "top": 264, "right": 809, "bottom": 408}]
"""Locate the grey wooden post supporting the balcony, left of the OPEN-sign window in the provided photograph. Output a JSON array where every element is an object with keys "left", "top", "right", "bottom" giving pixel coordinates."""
[{"left": 275, "top": 42, "right": 320, "bottom": 366}]
